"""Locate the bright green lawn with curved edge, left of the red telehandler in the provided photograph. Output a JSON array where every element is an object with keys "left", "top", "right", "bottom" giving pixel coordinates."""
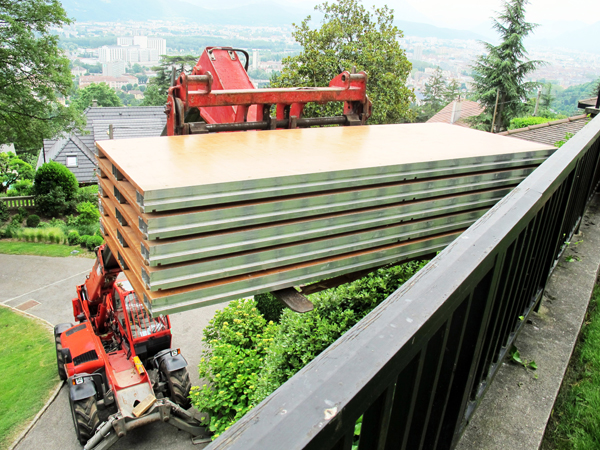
[{"left": 0, "top": 307, "right": 58, "bottom": 450}]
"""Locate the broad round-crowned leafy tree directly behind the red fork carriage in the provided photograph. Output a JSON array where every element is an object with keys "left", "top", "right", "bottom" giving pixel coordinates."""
[{"left": 271, "top": 0, "right": 414, "bottom": 123}]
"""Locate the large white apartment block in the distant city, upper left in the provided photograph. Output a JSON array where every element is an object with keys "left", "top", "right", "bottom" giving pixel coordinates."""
[{"left": 99, "top": 36, "right": 167, "bottom": 64}]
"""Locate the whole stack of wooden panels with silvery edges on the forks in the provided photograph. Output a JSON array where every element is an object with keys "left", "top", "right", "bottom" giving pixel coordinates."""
[{"left": 96, "top": 124, "right": 555, "bottom": 313}]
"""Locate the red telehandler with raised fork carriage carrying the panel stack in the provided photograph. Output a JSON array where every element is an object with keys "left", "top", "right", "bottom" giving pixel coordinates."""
[{"left": 54, "top": 47, "right": 371, "bottom": 450}]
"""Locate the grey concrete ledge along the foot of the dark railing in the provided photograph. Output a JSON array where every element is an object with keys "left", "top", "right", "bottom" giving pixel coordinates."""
[{"left": 456, "top": 196, "right": 600, "bottom": 450}]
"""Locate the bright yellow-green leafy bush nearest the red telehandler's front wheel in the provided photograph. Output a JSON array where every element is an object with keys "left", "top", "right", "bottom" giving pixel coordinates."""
[{"left": 190, "top": 300, "right": 276, "bottom": 437}]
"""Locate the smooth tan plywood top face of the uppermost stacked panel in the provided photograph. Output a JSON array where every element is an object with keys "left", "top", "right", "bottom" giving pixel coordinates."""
[{"left": 96, "top": 124, "right": 554, "bottom": 193}]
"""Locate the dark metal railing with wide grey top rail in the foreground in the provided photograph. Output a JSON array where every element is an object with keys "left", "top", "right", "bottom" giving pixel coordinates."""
[{"left": 208, "top": 113, "right": 600, "bottom": 450}]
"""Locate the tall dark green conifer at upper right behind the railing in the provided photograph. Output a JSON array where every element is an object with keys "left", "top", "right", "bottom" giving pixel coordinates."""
[{"left": 472, "top": 0, "right": 544, "bottom": 132}]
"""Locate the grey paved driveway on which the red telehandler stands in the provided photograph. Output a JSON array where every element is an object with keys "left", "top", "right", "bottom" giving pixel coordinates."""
[{"left": 0, "top": 254, "right": 219, "bottom": 450}]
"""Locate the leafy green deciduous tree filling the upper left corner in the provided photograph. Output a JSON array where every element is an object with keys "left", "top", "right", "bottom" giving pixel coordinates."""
[{"left": 0, "top": 0, "right": 85, "bottom": 148}]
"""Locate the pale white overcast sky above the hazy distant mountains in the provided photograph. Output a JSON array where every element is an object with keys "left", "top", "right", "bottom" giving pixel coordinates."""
[{"left": 278, "top": 0, "right": 600, "bottom": 29}]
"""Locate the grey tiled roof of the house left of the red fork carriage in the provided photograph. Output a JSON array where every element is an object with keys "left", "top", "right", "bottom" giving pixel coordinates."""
[{"left": 36, "top": 106, "right": 167, "bottom": 181}]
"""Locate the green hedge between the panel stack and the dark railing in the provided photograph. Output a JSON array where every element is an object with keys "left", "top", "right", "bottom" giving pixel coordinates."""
[{"left": 191, "top": 261, "right": 426, "bottom": 436}]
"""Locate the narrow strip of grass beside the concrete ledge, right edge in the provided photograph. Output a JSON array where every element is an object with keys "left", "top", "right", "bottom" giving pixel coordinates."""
[{"left": 541, "top": 285, "right": 600, "bottom": 450}]
